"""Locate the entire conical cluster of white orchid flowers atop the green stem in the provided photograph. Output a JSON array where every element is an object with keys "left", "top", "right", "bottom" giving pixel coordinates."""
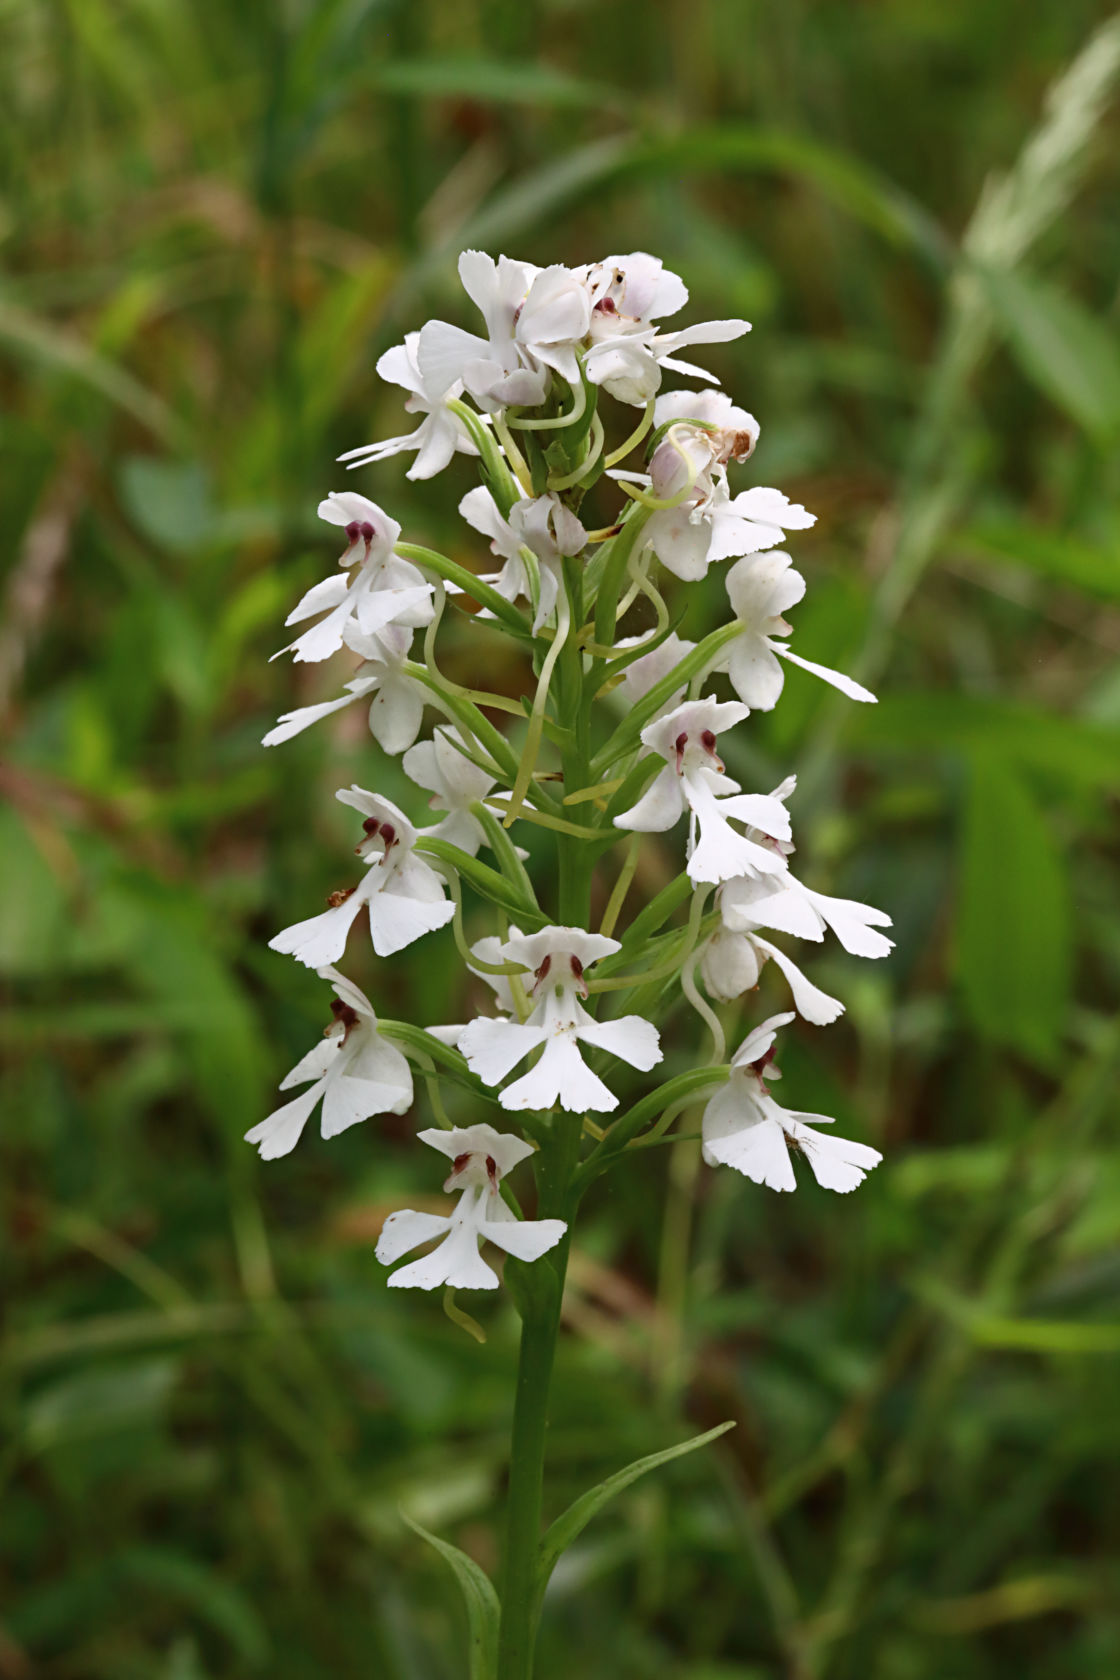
[{"left": 247, "top": 250, "right": 890, "bottom": 1289}]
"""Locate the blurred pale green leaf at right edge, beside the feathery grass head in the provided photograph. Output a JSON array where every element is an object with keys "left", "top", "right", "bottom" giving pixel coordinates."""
[{"left": 979, "top": 267, "right": 1120, "bottom": 438}]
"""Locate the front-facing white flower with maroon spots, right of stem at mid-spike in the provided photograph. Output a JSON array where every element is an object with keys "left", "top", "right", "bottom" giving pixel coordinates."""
[{"left": 615, "top": 699, "right": 789, "bottom": 882}]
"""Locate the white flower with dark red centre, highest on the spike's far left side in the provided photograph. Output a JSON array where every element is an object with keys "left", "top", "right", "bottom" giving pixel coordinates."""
[{"left": 272, "top": 491, "right": 433, "bottom": 662}]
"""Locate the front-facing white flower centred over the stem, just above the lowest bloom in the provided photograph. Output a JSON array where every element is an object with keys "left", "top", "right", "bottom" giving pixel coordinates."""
[{"left": 458, "top": 927, "right": 662, "bottom": 1112}]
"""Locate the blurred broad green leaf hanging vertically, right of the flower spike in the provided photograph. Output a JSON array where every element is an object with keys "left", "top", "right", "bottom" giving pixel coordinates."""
[{"left": 955, "top": 753, "right": 1070, "bottom": 1060}]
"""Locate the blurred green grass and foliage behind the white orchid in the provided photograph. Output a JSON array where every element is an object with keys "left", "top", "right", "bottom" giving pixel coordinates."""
[{"left": 0, "top": 0, "right": 1120, "bottom": 1680}]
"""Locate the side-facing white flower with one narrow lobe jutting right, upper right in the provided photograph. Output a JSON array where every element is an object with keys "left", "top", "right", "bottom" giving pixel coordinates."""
[{"left": 719, "top": 549, "right": 875, "bottom": 712}]
